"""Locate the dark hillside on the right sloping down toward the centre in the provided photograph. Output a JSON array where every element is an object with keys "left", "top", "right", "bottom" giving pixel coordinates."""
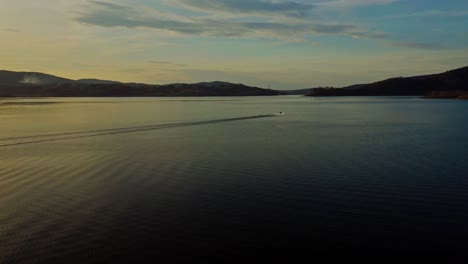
[{"left": 309, "top": 67, "right": 468, "bottom": 98}]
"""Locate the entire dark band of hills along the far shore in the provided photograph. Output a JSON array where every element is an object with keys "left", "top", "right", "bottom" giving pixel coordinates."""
[{"left": 0, "top": 67, "right": 468, "bottom": 100}]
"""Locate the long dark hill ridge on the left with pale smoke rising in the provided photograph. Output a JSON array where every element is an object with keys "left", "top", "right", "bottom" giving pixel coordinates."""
[{"left": 0, "top": 71, "right": 280, "bottom": 97}]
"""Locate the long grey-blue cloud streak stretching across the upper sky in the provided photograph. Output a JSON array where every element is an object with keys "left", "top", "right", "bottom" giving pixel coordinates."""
[{"left": 75, "top": 0, "right": 373, "bottom": 40}]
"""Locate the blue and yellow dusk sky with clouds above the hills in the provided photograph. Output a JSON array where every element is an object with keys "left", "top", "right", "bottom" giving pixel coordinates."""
[{"left": 0, "top": 0, "right": 468, "bottom": 89}]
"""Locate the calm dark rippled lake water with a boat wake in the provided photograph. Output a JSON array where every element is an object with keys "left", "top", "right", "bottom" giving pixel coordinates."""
[{"left": 0, "top": 97, "right": 468, "bottom": 263}]
